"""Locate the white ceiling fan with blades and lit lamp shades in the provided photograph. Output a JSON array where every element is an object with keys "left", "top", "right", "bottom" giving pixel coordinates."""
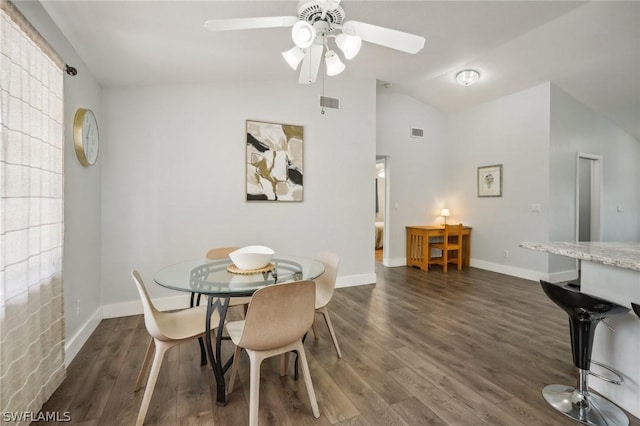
[{"left": 204, "top": 0, "right": 425, "bottom": 84}]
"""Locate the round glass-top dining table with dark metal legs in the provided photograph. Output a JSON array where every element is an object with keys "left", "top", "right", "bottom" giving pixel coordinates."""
[{"left": 154, "top": 255, "right": 324, "bottom": 405}]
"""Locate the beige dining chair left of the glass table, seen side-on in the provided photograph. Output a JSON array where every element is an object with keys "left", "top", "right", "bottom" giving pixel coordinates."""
[{"left": 131, "top": 270, "right": 220, "bottom": 425}]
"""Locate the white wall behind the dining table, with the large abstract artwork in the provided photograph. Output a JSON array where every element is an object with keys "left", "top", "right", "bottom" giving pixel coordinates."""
[{"left": 102, "top": 79, "right": 376, "bottom": 310}]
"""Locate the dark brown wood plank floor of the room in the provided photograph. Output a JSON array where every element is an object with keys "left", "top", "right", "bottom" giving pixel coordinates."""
[{"left": 37, "top": 263, "right": 640, "bottom": 426}]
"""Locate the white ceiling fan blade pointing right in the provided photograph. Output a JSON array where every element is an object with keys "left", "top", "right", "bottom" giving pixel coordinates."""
[{"left": 342, "top": 21, "right": 425, "bottom": 53}]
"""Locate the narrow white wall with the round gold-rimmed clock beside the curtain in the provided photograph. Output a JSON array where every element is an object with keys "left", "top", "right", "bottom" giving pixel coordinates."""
[{"left": 15, "top": 2, "right": 105, "bottom": 363}]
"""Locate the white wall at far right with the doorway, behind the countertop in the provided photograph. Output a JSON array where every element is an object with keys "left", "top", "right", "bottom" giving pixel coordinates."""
[{"left": 549, "top": 84, "right": 640, "bottom": 272}]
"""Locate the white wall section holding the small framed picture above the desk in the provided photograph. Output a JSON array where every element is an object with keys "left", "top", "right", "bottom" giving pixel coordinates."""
[{"left": 447, "top": 83, "right": 550, "bottom": 279}]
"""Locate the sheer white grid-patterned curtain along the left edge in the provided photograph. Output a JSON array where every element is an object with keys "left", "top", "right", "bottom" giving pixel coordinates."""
[{"left": 0, "top": 0, "right": 65, "bottom": 423}]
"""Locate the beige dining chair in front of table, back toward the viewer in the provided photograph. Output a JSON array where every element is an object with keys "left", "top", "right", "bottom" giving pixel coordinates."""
[{"left": 227, "top": 281, "right": 320, "bottom": 426}]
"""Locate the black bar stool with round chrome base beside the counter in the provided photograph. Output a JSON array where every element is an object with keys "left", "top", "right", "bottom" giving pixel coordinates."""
[{"left": 540, "top": 281, "right": 629, "bottom": 426}]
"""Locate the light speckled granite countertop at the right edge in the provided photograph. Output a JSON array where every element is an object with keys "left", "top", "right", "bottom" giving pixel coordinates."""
[{"left": 520, "top": 241, "right": 640, "bottom": 272}]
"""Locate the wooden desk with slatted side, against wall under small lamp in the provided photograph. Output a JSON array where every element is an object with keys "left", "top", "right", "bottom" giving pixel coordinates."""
[{"left": 407, "top": 225, "right": 471, "bottom": 271}]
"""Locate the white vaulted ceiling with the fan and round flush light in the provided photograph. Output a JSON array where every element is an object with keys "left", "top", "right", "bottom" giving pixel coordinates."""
[{"left": 40, "top": 0, "right": 640, "bottom": 140}]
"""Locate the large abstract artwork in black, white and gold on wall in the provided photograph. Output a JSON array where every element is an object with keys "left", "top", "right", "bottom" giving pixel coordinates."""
[{"left": 246, "top": 120, "right": 304, "bottom": 202}]
